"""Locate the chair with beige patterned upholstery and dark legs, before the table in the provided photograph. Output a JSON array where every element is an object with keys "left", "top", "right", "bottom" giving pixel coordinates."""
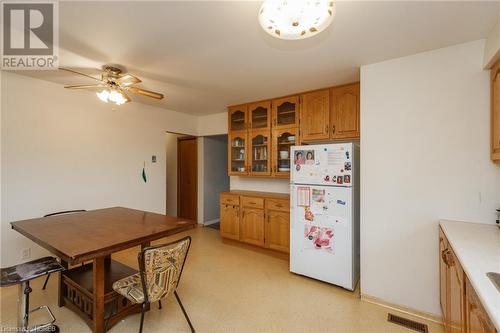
[{"left": 113, "top": 236, "right": 195, "bottom": 333}]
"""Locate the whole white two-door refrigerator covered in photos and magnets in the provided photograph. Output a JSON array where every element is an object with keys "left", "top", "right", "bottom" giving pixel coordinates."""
[{"left": 290, "top": 143, "right": 359, "bottom": 290}]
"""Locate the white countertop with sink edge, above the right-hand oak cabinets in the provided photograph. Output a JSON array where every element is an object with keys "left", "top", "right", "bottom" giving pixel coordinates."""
[{"left": 439, "top": 220, "right": 500, "bottom": 332}]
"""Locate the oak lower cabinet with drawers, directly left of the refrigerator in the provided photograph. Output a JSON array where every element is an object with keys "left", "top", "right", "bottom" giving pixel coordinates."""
[{"left": 220, "top": 191, "right": 290, "bottom": 253}]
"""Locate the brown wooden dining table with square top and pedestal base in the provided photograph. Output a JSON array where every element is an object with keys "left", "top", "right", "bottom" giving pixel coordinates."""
[{"left": 11, "top": 207, "right": 196, "bottom": 333}]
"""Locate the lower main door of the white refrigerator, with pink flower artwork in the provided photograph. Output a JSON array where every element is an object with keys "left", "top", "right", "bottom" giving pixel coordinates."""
[{"left": 290, "top": 185, "right": 354, "bottom": 290}]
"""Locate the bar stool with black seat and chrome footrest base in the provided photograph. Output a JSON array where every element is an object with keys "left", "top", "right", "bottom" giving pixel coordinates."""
[{"left": 0, "top": 257, "right": 64, "bottom": 333}]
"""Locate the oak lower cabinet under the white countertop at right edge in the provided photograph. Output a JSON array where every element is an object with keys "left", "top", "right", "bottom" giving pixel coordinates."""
[{"left": 439, "top": 229, "right": 496, "bottom": 333}]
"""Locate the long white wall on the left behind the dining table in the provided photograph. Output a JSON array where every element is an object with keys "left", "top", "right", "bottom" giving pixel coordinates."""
[{"left": 1, "top": 72, "right": 198, "bottom": 267}]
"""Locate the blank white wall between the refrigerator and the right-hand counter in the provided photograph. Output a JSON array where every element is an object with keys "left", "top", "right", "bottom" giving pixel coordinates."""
[{"left": 361, "top": 41, "right": 500, "bottom": 315}]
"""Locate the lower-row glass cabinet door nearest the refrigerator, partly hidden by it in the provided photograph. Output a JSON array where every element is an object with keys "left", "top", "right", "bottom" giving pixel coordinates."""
[{"left": 272, "top": 127, "right": 299, "bottom": 178}]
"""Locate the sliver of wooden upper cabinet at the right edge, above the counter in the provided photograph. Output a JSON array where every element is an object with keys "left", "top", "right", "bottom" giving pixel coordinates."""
[{"left": 491, "top": 61, "right": 500, "bottom": 162}]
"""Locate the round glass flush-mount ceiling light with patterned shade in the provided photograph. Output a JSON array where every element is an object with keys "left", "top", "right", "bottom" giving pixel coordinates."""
[{"left": 259, "top": 0, "right": 335, "bottom": 39}]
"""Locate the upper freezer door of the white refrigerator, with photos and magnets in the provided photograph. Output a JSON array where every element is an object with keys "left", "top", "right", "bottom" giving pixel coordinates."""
[{"left": 290, "top": 143, "right": 353, "bottom": 187}]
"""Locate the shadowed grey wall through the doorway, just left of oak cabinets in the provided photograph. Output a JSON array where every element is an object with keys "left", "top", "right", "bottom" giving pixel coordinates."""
[{"left": 203, "top": 135, "right": 229, "bottom": 224}]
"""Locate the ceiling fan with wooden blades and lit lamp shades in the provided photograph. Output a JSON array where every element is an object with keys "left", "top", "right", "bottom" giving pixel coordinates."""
[{"left": 59, "top": 66, "right": 163, "bottom": 105}]
